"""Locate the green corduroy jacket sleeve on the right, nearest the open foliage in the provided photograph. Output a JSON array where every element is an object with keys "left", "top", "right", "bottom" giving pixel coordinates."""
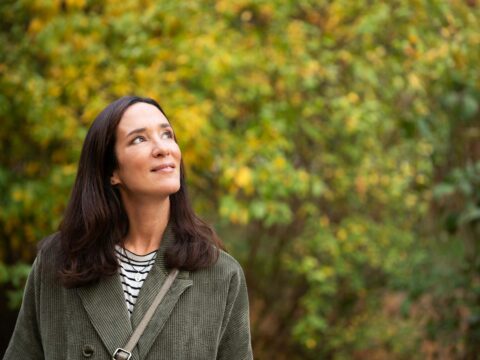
[{"left": 217, "top": 267, "right": 253, "bottom": 360}]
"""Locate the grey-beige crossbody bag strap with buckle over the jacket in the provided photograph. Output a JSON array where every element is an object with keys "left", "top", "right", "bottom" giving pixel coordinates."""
[{"left": 113, "top": 269, "right": 178, "bottom": 360}]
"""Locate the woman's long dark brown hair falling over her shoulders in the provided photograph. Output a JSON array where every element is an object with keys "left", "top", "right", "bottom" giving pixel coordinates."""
[{"left": 57, "top": 96, "right": 223, "bottom": 288}]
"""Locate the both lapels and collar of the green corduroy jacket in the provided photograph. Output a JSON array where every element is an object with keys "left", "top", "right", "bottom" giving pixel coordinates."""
[{"left": 77, "top": 223, "right": 193, "bottom": 359}]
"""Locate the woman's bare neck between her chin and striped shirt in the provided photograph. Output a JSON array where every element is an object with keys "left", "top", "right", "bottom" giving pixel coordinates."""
[{"left": 122, "top": 196, "right": 170, "bottom": 255}]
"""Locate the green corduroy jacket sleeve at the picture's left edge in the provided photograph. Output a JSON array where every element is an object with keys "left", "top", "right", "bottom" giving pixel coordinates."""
[{"left": 3, "top": 257, "right": 44, "bottom": 360}]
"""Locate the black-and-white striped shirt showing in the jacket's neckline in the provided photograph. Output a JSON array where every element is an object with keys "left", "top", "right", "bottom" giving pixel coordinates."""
[{"left": 115, "top": 245, "right": 157, "bottom": 315}]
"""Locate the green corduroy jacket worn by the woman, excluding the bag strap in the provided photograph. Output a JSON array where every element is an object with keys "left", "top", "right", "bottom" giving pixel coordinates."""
[{"left": 4, "top": 229, "right": 253, "bottom": 360}]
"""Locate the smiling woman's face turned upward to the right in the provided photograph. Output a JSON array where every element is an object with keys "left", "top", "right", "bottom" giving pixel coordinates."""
[{"left": 110, "top": 102, "right": 182, "bottom": 197}]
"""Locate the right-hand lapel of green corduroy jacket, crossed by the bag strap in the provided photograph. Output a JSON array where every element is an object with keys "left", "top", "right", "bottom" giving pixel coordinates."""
[{"left": 131, "top": 226, "right": 193, "bottom": 359}]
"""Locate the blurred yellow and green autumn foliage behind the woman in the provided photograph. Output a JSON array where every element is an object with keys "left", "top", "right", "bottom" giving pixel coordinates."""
[{"left": 0, "top": 0, "right": 480, "bottom": 360}]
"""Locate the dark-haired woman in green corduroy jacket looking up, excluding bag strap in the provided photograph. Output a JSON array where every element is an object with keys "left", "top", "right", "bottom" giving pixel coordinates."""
[{"left": 4, "top": 96, "right": 252, "bottom": 360}]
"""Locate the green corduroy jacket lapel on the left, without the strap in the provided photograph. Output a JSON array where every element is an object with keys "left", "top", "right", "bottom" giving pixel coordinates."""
[{"left": 77, "top": 275, "right": 132, "bottom": 354}]
